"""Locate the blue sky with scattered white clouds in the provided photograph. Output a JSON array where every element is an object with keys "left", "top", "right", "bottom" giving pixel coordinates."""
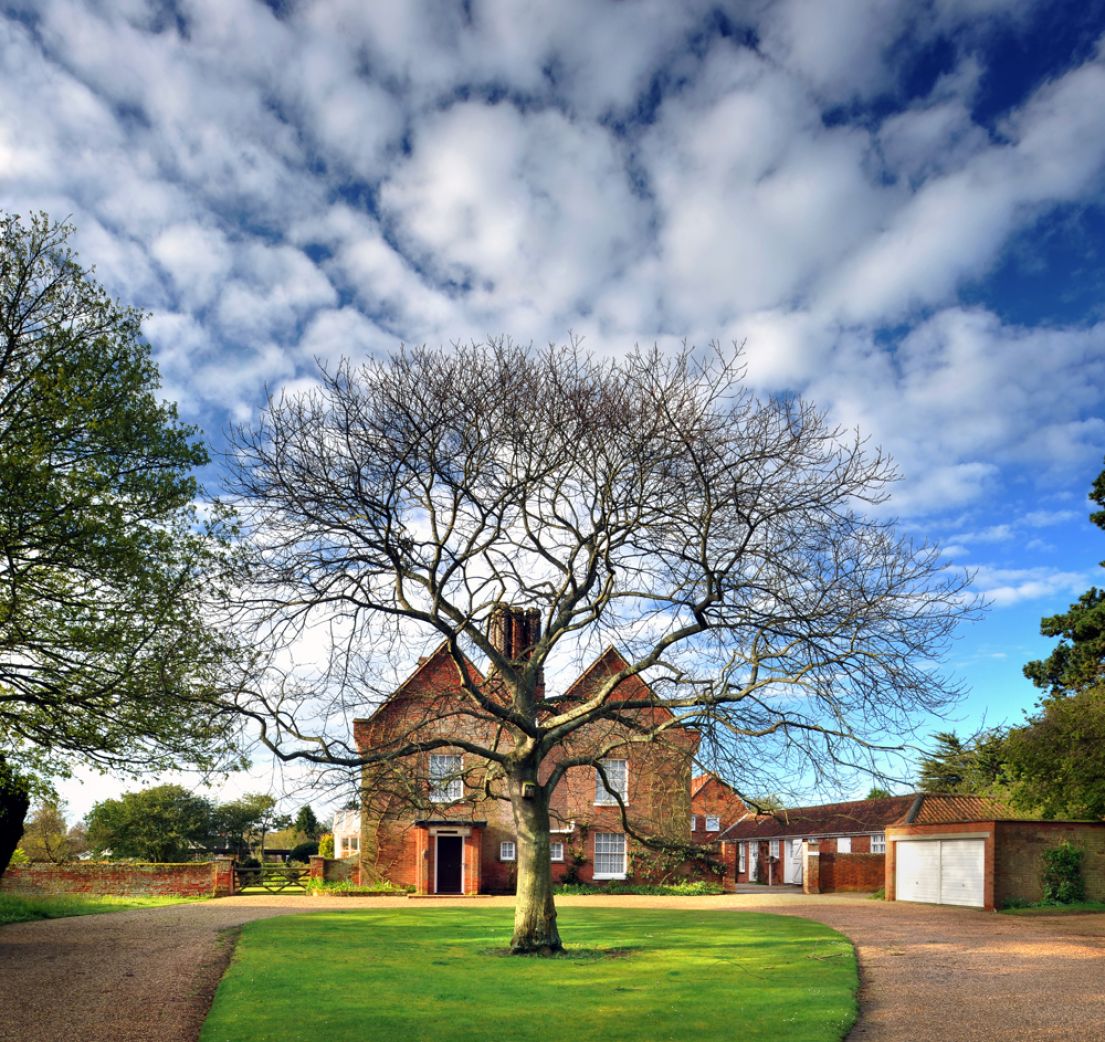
[{"left": 0, "top": 0, "right": 1105, "bottom": 813}]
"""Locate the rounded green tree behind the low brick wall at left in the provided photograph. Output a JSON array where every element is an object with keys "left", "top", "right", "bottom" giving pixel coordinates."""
[{"left": 86, "top": 785, "right": 214, "bottom": 862}]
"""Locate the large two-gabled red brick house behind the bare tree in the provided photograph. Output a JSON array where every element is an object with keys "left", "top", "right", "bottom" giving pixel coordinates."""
[{"left": 354, "top": 609, "right": 698, "bottom": 894}]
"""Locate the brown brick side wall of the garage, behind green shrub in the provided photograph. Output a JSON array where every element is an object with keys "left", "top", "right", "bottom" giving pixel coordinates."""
[{"left": 993, "top": 821, "right": 1105, "bottom": 908}]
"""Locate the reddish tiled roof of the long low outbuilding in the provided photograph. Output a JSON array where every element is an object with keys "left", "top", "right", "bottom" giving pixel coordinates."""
[{"left": 718, "top": 792, "right": 1009, "bottom": 841}]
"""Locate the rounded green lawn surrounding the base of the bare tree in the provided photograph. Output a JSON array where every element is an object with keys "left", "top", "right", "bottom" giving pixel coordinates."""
[{"left": 201, "top": 906, "right": 857, "bottom": 1042}]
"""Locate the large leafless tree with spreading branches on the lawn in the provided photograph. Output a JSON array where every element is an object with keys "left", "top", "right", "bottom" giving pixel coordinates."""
[{"left": 228, "top": 340, "right": 972, "bottom": 951}]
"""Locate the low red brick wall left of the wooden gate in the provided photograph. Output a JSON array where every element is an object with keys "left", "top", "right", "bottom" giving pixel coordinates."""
[{"left": 0, "top": 861, "right": 233, "bottom": 897}]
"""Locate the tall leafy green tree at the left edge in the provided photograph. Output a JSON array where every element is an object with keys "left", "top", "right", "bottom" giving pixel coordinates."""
[{"left": 0, "top": 213, "right": 235, "bottom": 872}]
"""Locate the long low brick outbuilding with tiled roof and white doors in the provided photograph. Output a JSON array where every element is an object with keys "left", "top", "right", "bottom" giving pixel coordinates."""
[{"left": 720, "top": 793, "right": 1007, "bottom": 893}]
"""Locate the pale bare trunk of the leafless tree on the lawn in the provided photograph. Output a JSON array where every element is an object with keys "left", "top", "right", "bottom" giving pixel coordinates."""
[{"left": 508, "top": 769, "right": 564, "bottom": 955}]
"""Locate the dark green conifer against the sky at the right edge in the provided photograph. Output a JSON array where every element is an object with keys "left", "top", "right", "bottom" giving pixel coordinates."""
[{"left": 1024, "top": 459, "right": 1105, "bottom": 697}]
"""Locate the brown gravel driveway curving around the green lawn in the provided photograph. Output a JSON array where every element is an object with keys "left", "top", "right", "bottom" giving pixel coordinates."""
[{"left": 0, "top": 893, "right": 1105, "bottom": 1042}]
